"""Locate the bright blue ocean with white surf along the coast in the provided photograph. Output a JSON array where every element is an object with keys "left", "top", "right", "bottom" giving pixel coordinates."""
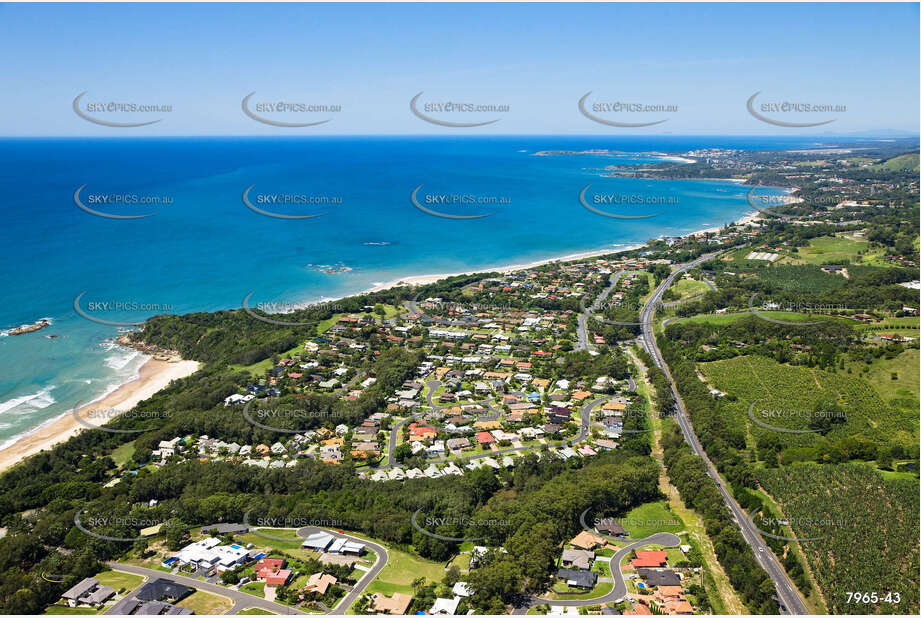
[{"left": 0, "top": 136, "right": 828, "bottom": 445}]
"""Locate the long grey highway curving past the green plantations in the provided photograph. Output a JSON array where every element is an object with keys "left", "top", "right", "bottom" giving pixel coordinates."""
[{"left": 640, "top": 252, "right": 809, "bottom": 615}]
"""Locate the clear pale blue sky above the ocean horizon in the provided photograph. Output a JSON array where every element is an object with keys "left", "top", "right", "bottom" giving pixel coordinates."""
[{"left": 0, "top": 3, "right": 919, "bottom": 136}]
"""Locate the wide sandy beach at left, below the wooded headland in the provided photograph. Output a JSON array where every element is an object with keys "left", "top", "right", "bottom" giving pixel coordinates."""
[{"left": 0, "top": 357, "right": 199, "bottom": 471}]
